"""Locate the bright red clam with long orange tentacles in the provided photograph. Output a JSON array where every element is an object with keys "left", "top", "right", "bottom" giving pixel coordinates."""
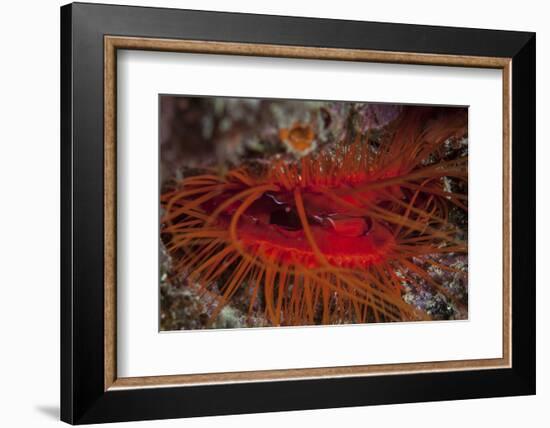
[{"left": 161, "top": 109, "right": 468, "bottom": 326}]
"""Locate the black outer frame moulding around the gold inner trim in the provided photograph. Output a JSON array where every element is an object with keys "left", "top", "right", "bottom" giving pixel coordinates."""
[{"left": 61, "top": 3, "right": 536, "bottom": 424}]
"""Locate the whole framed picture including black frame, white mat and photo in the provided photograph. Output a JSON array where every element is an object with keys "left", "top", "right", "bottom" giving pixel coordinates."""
[{"left": 61, "top": 3, "right": 536, "bottom": 424}]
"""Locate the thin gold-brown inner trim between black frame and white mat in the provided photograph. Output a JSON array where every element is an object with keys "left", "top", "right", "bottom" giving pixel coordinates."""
[{"left": 104, "top": 36, "right": 512, "bottom": 391}]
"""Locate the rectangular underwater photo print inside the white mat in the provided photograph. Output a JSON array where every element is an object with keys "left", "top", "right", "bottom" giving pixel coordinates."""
[{"left": 159, "top": 95, "right": 468, "bottom": 331}]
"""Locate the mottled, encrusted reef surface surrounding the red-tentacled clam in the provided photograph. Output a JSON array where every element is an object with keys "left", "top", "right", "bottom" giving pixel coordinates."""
[{"left": 159, "top": 96, "right": 468, "bottom": 331}]
